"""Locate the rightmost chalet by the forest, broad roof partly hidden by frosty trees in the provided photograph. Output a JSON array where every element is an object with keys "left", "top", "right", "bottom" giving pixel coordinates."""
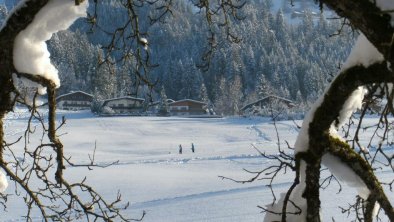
[{"left": 241, "top": 95, "right": 295, "bottom": 115}]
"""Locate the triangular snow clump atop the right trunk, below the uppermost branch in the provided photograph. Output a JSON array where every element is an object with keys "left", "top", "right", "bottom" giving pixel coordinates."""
[{"left": 342, "top": 34, "right": 384, "bottom": 70}]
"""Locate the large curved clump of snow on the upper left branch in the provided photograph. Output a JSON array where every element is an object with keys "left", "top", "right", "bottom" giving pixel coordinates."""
[{"left": 13, "top": 0, "right": 88, "bottom": 91}]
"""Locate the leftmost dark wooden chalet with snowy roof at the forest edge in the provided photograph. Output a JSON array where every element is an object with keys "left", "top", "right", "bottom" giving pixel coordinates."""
[{"left": 56, "top": 91, "right": 93, "bottom": 110}]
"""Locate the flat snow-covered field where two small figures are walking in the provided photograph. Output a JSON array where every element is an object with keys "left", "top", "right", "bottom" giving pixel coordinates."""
[{"left": 0, "top": 110, "right": 394, "bottom": 221}]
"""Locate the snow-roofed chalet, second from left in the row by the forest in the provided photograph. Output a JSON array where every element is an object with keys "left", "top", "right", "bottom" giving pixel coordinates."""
[{"left": 102, "top": 96, "right": 145, "bottom": 115}]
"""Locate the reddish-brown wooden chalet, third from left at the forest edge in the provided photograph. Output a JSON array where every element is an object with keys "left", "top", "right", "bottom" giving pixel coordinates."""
[{"left": 168, "top": 99, "right": 207, "bottom": 116}]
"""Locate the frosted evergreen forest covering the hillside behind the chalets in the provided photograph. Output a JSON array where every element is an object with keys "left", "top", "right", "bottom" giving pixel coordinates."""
[{"left": 0, "top": 0, "right": 355, "bottom": 115}]
